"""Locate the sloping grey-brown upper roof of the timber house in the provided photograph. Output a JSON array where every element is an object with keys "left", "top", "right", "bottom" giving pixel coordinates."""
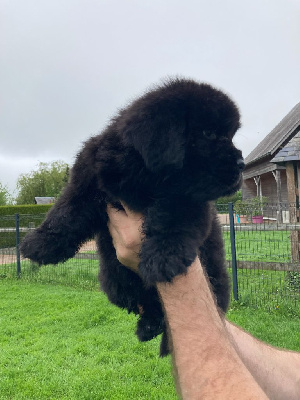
[{"left": 245, "top": 103, "right": 300, "bottom": 166}]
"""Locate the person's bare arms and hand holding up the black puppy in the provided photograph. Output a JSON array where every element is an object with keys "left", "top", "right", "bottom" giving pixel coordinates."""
[{"left": 107, "top": 205, "right": 300, "bottom": 400}]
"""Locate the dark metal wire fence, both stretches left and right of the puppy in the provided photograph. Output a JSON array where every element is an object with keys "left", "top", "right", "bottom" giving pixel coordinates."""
[{"left": 0, "top": 204, "right": 300, "bottom": 309}]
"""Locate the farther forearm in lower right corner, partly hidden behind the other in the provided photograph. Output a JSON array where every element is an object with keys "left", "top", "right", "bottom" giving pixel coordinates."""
[{"left": 226, "top": 321, "right": 300, "bottom": 400}]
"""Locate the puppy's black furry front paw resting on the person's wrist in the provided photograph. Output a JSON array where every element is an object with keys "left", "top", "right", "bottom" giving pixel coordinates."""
[{"left": 139, "top": 236, "right": 196, "bottom": 286}]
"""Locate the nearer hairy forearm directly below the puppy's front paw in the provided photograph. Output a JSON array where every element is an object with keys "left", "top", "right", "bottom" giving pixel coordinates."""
[{"left": 157, "top": 259, "right": 267, "bottom": 400}]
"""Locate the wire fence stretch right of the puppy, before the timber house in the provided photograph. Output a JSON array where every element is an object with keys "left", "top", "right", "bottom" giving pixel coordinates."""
[{"left": 219, "top": 203, "right": 300, "bottom": 310}]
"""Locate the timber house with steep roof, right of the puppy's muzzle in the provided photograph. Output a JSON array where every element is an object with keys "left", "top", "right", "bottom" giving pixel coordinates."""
[{"left": 243, "top": 103, "right": 300, "bottom": 208}]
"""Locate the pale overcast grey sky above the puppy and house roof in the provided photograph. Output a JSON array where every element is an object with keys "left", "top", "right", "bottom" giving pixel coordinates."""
[{"left": 0, "top": 0, "right": 300, "bottom": 191}]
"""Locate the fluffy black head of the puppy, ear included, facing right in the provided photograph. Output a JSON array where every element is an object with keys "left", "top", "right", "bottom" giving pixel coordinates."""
[{"left": 118, "top": 79, "right": 244, "bottom": 200}]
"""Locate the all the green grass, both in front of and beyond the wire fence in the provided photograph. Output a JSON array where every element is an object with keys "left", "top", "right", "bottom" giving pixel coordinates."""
[{"left": 0, "top": 231, "right": 300, "bottom": 400}]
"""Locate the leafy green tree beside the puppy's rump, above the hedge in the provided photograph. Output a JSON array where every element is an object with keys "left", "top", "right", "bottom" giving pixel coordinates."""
[{"left": 16, "top": 161, "right": 69, "bottom": 204}]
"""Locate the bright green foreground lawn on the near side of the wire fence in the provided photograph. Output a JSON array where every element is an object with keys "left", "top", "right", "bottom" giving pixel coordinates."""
[{"left": 0, "top": 279, "right": 300, "bottom": 400}]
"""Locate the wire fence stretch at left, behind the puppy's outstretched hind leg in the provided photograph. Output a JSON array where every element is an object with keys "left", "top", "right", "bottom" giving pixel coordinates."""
[{"left": 0, "top": 214, "right": 99, "bottom": 290}]
